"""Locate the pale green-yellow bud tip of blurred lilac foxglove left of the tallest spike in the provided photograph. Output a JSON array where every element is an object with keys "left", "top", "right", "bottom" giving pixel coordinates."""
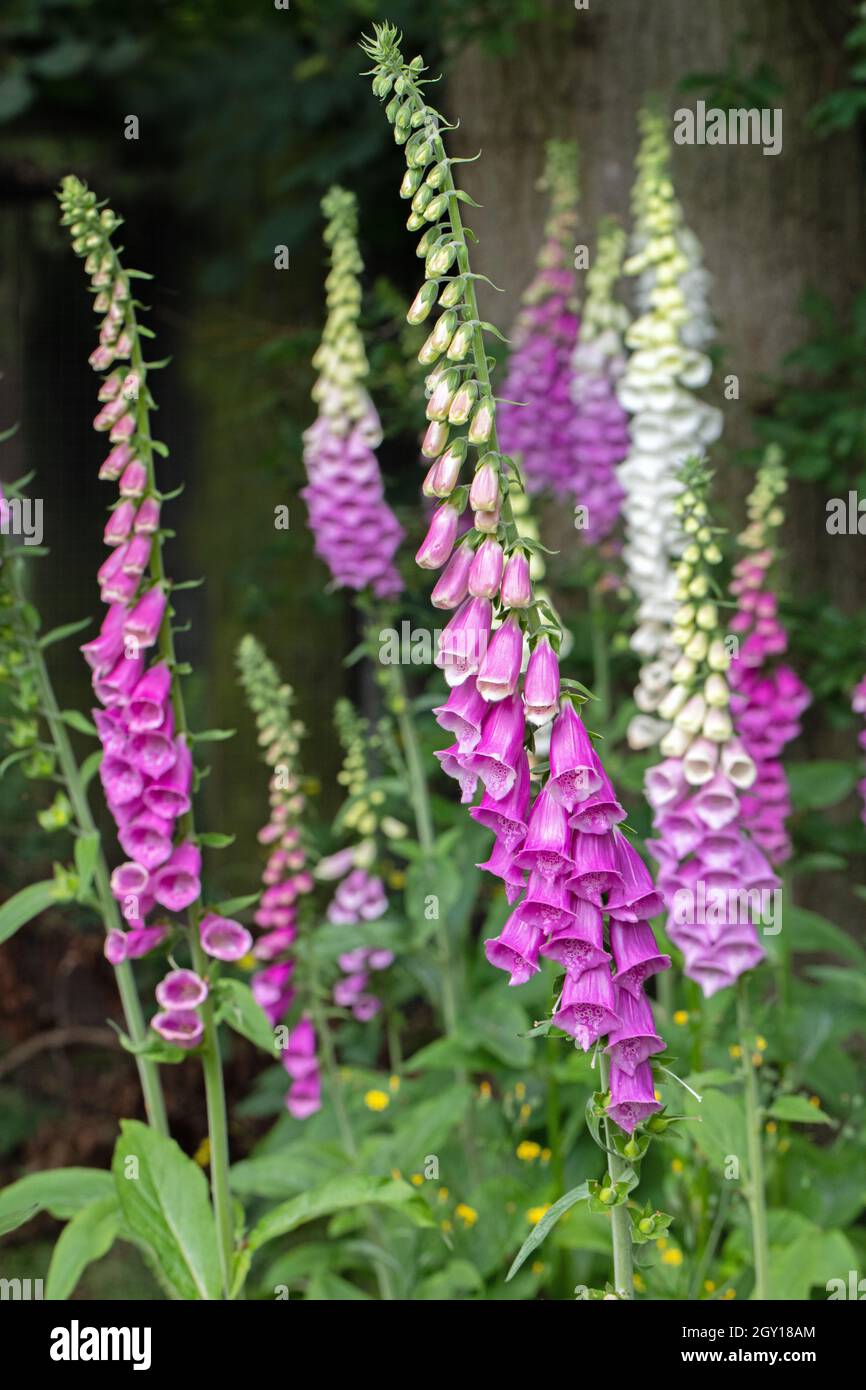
[{"left": 311, "top": 186, "right": 371, "bottom": 425}]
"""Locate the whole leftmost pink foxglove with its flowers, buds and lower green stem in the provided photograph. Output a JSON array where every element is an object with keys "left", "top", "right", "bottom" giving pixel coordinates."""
[{"left": 58, "top": 175, "right": 234, "bottom": 1293}]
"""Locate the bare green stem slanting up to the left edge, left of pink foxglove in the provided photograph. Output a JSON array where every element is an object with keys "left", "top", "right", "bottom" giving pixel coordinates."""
[{"left": 13, "top": 550, "right": 168, "bottom": 1136}]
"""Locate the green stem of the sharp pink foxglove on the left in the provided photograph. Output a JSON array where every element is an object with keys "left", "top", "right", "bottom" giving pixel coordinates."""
[{"left": 123, "top": 298, "right": 235, "bottom": 1298}]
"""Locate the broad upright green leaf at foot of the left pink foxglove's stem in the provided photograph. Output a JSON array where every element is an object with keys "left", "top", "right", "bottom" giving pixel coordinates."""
[{"left": 111, "top": 1120, "right": 221, "bottom": 1301}]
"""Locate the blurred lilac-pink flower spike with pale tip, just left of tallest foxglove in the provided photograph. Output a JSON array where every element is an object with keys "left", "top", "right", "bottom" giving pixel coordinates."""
[{"left": 303, "top": 188, "right": 403, "bottom": 598}]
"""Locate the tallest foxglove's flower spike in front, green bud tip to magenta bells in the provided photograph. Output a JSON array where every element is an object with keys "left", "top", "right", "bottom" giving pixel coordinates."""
[{"left": 364, "top": 26, "right": 670, "bottom": 1150}]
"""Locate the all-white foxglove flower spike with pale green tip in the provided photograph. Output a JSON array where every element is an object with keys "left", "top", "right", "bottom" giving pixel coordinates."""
[{"left": 619, "top": 110, "right": 721, "bottom": 748}]
